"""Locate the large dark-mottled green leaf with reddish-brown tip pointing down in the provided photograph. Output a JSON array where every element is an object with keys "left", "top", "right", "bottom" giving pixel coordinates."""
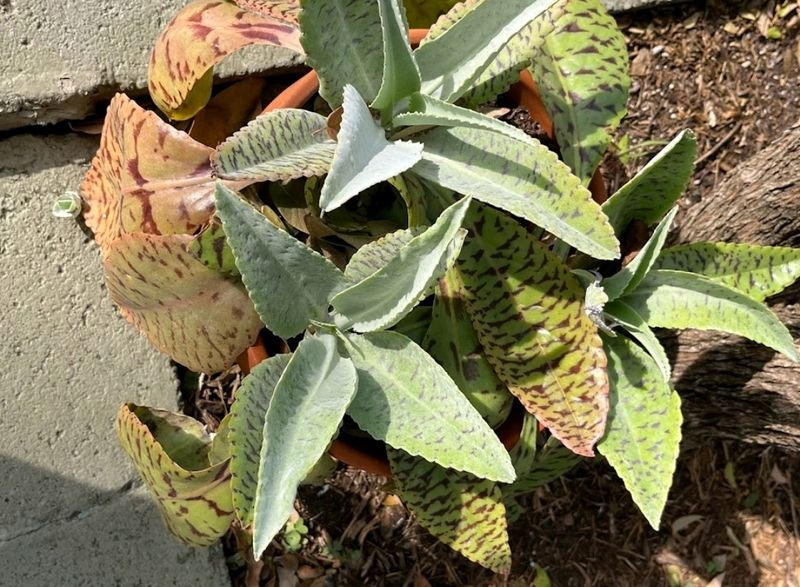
[{"left": 457, "top": 206, "right": 608, "bottom": 456}]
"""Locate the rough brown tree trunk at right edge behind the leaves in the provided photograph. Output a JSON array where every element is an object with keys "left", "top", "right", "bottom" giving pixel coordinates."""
[{"left": 663, "top": 122, "right": 800, "bottom": 451}]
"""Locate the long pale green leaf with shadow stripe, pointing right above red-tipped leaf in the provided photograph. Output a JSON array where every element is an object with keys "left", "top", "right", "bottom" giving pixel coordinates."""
[{"left": 413, "top": 128, "right": 619, "bottom": 259}]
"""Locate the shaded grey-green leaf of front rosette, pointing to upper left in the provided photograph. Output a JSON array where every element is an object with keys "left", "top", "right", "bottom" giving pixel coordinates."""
[{"left": 217, "top": 184, "right": 346, "bottom": 338}]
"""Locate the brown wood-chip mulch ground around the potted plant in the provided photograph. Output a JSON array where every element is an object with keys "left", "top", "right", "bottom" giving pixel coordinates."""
[{"left": 181, "top": 2, "right": 800, "bottom": 587}]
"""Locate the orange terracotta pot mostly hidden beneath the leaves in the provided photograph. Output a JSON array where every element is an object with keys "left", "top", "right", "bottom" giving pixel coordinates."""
[{"left": 239, "top": 29, "right": 606, "bottom": 477}]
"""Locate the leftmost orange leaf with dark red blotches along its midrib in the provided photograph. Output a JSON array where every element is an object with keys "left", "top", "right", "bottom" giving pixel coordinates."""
[{"left": 80, "top": 94, "right": 220, "bottom": 251}]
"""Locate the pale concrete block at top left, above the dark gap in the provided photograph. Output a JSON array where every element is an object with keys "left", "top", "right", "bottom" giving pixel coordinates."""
[{"left": 0, "top": 0, "right": 301, "bottom": 130}]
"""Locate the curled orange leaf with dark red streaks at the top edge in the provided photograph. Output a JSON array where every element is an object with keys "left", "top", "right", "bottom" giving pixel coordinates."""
[{"left": 147, "top": 0, "right": 303, "bottom": 120}]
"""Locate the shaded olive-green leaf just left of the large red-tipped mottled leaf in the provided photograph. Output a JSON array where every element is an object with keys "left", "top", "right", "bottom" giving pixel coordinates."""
[{"left": 422, "top": 268, "right": 514, "bottom": 428}]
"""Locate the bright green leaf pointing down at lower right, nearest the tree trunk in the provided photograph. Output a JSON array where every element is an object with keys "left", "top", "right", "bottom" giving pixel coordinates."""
[{"left": 597, "top": 336, "right": 683, "bottom": 530}]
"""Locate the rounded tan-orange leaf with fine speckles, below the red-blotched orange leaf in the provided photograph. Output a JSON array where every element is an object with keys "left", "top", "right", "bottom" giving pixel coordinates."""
[{"left": 103, "top": 234, "right": 261, "bottom": 373}]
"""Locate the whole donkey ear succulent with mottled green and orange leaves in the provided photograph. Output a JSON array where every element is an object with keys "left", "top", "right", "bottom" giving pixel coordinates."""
[{"left": 82, "top": 0, "right": 800, "bottom": 573}]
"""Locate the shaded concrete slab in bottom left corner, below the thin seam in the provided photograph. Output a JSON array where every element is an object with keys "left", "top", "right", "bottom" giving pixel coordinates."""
[{"left": 0, "top": 488, "right": 230, "bottom": 587}]
